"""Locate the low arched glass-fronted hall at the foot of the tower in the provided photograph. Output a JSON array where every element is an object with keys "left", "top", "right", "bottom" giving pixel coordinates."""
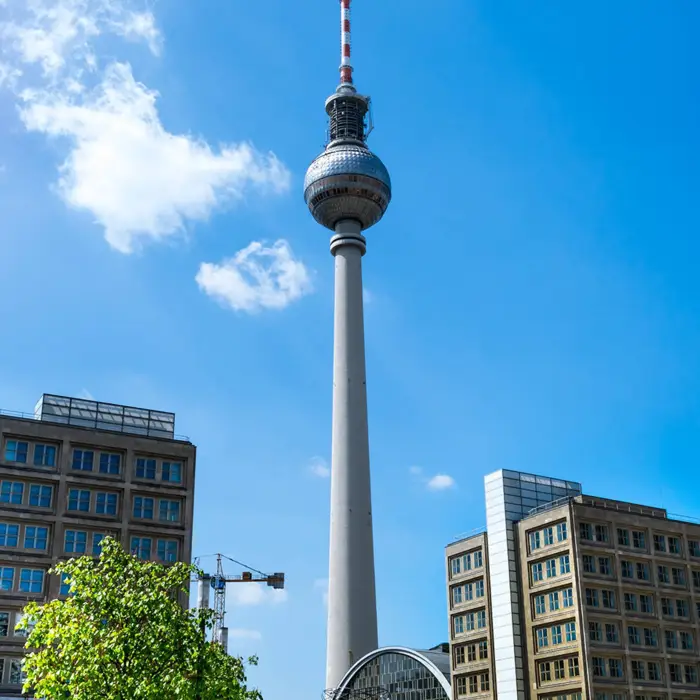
[{"left": 331, "top": 644, "right": 451, "bottom": 700}]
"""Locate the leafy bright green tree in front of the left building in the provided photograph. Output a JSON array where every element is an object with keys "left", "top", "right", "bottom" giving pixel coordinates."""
[{"left": 18, "top": 538, "right": 261, "bottom": 700}]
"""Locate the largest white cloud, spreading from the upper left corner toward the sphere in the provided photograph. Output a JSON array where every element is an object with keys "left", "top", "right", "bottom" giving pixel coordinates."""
[{"left": 0, "top": 0, "right": 290, "bottom": 253}]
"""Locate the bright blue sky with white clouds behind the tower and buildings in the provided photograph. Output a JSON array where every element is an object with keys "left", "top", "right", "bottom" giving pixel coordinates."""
[{"left": 0, "top": 0, "right": 700, "bottom": 700}]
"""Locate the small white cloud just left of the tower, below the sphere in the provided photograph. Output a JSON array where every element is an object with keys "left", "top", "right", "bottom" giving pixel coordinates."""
[{"left": 195, "top": 240, "right": 313, "bottom": 313}]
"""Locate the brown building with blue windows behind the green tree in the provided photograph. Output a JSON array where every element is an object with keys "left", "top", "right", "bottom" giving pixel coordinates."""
[{"left": 0, "top": 394, "right": 196, "bottom": 697}]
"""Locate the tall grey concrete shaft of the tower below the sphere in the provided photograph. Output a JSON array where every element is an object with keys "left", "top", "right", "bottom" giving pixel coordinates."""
[{"left": 326, "top": 220, "right": 378, "bottom": 688}]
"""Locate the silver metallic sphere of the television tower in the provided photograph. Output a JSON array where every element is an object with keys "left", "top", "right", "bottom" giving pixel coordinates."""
[{"left": 304, "top": 142, "right": 391, "bottom": 230}]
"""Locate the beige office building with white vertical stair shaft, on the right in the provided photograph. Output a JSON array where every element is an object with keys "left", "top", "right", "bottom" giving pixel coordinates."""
[{"left": 446, "top": 471, "right": 700, "bottom": 700}]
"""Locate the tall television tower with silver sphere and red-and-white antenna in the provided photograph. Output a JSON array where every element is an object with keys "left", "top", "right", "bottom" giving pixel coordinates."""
[{"left": 304, "top": 0, "right": 391, "bottom": 688}]
